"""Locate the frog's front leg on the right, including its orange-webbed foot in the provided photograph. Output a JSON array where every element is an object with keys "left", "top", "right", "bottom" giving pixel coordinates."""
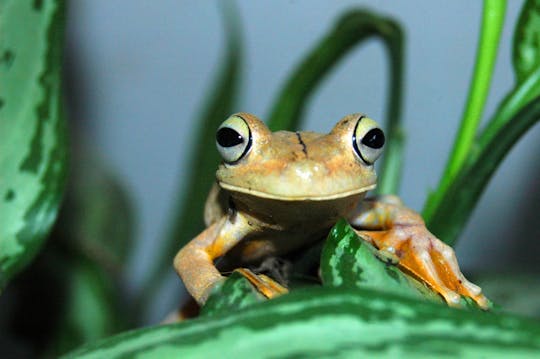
[{"left": 349, "top": 196, "right": 488, "bottom": 309}]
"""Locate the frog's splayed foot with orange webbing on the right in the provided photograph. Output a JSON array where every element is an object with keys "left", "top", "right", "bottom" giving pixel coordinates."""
[{"left": 356, "top": 225, "right": 489, "bottom": 309}]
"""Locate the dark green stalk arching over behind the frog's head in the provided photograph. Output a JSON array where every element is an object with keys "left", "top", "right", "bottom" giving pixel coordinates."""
[{"left": 268, "top": 10, "right": 404, "bottom": 193}]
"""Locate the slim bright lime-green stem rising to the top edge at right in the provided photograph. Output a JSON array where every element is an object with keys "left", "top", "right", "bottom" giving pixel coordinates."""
[{"left": 423, "top": 0, "right": 506, "bottom": 222}]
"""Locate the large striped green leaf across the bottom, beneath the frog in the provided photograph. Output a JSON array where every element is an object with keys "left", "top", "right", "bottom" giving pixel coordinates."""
[{"left": 66, "top": 288, "right": 540, "bottom": 358}]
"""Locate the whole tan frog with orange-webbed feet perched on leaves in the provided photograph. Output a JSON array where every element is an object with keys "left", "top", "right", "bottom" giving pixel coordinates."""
[{"left": 174, "top": 112, "right": 489, "bottom": 309}]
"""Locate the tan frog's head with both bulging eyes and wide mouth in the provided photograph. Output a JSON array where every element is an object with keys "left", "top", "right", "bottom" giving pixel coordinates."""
[{"left": 216, "top": 113, "right": 384, "bottom": 201}]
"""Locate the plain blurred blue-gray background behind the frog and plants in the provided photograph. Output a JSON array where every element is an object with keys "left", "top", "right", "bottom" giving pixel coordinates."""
[{"left": 67, "top": 0, "right": 540, "bottom": 318}]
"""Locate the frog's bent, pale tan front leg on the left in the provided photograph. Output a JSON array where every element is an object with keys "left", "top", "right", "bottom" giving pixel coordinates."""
[{"left": 174, "top": 212, "right": 256, "bottom": 304}]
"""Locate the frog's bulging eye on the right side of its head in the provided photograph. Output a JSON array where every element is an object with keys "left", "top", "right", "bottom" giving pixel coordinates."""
[{"left": 353, "top": 116, "right": 384, "bottom": 165}]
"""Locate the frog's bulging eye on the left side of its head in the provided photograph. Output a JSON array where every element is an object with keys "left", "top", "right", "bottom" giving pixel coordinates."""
[{"left": 216, "top": 116, "right": 251, "bottom": 164}]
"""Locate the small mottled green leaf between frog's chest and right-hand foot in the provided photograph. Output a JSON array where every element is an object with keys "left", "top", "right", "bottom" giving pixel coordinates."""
[{"left": 321, "top": 219, "right": 443, "bottom": 303}]
